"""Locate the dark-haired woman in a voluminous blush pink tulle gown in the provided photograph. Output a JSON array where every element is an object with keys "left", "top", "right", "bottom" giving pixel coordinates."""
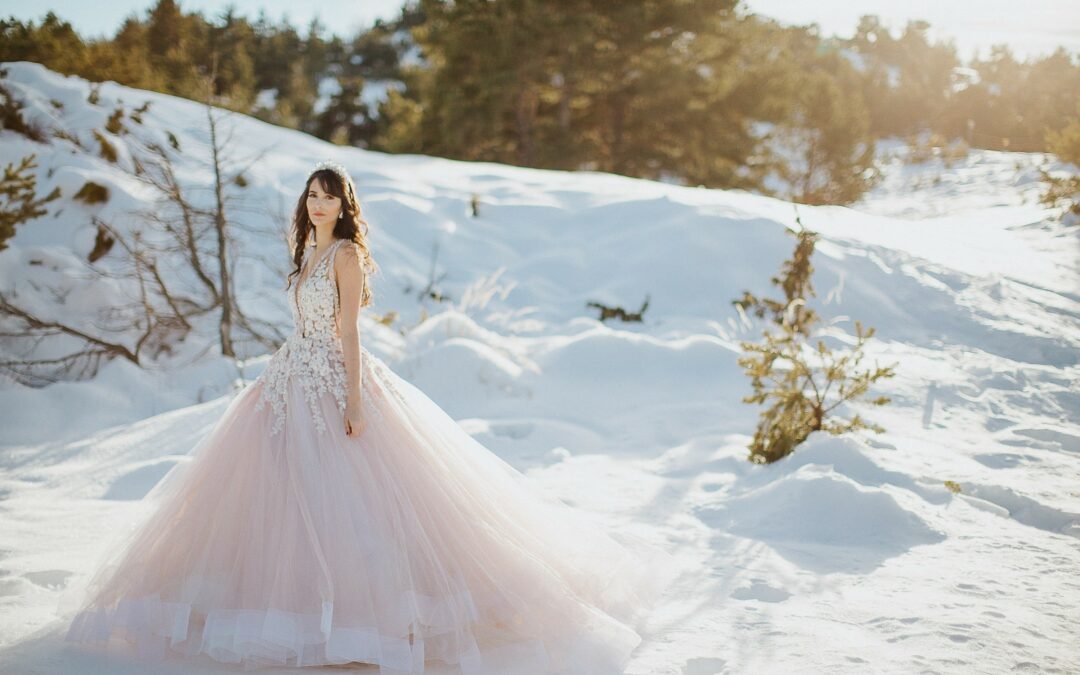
[{"left": 66, "top": 162, "right": 674, "bottom": 675}]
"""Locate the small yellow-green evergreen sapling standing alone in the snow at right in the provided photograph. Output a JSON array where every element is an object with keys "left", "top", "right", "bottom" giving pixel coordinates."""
[{"left": 732, "top": 218, "right": 896, "bottom": 464}]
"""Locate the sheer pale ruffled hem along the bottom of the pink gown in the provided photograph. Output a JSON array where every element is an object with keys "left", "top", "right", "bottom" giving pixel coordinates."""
[{"left": 65, "top": 596, "right": 640, "bottom": 675}]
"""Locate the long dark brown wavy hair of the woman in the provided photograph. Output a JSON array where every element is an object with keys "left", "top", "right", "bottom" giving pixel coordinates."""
[{"left": 285, "top": 168, "right": 379, "bottom": 307}]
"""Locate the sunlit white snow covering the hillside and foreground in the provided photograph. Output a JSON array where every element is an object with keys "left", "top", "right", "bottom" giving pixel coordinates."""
[{"left": 0, "top": 63, "right": 1080, "bottom": 675}]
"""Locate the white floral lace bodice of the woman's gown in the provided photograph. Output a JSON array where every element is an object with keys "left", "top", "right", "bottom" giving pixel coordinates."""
[{"left": 255, "top": 240, "right": 388, "bottom": 435}]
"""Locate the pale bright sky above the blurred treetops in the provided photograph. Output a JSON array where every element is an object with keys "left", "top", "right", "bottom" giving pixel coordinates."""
[{"left": 0, "top": 0, "right": 1080, "bottom": 62}]
